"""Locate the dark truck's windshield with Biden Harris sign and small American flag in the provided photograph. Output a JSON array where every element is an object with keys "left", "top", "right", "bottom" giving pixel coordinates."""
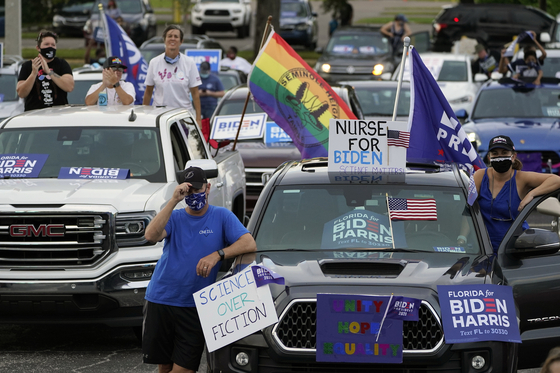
[{"left": 255, "top": 184, "right": 480, "bottom": 254}]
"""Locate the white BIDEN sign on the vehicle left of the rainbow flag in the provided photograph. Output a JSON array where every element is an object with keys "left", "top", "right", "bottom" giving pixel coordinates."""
[{"left": 210, "top": 113, "right": 266, "bottom": 140}]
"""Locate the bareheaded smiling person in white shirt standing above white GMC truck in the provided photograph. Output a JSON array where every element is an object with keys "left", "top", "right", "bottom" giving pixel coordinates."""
[{"left": 143, "top": 25, "right": 202, "bottom": 126}]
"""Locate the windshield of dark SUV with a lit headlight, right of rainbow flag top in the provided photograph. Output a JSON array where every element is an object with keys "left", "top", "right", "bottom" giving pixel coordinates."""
[{"left": 325, "top": 33, "right": 390, "bottom": 55}]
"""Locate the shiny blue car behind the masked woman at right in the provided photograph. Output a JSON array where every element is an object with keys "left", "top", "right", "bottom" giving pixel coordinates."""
[{"left": 463, "top": 78, "right": 560, "bottom": 174}]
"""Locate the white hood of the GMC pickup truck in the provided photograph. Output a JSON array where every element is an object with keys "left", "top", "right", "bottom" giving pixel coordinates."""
[{"left": 0, "top": 179, "right": 166, "bottom": 212}]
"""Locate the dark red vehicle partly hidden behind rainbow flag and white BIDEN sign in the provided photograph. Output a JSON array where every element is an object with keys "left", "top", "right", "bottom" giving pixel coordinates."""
[{"left": 211, "top": 85, "right": 364, "bottom": 213}]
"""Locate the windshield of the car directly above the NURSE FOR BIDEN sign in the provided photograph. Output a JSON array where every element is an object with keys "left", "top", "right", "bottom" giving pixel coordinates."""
[{"left": 354, "top": 86, "right": 410, "bottom": 116}]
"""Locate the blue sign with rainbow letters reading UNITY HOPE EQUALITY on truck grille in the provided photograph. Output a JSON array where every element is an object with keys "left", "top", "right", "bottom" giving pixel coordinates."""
[{"left": 316, "top": 294, "right": 403, "bottom": 364}]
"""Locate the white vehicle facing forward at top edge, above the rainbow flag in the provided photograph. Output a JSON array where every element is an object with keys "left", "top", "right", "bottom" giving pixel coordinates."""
[{"left": 191, "top": 0, "right": 253, "bottom": 39}]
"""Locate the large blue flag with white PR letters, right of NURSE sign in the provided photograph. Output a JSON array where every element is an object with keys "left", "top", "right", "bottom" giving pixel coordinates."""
[{"left": 407, "top": 47, "right": 486, "bottom": 172}]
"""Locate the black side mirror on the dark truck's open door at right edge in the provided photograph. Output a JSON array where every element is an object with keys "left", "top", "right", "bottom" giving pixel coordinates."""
[{"left": 506, "top": 228, "right": 560, "bottom": 258}]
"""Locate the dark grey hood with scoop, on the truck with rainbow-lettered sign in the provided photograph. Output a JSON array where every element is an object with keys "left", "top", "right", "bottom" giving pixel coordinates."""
[{"left": 257, "top": 251, "right": 492, "bottom": 296}]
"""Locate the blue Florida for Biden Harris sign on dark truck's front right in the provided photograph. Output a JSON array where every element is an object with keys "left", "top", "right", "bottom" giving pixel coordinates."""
[{"left": 437, "top": 285, "right": 521, "bottom": 343}]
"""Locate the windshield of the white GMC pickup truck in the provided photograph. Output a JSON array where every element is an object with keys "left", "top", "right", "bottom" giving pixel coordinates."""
[{"left": 0, "top": 127, "right": 165, "bottom": 182}]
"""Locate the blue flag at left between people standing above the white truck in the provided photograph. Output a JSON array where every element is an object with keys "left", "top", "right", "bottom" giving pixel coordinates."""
[{"left": 105, "top": 14, "right": 148, "bottom": 105}]
